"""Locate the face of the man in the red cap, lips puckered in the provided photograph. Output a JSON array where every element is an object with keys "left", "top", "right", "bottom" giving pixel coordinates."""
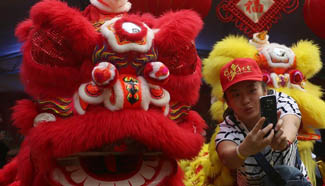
[{"left": 226, "top": 81, "right": 266, "bottom": 125}]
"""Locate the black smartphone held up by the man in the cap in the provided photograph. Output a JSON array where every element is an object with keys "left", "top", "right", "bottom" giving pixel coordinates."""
[{"left": 260, "top": 95, "right": 278, "bottom": 129}]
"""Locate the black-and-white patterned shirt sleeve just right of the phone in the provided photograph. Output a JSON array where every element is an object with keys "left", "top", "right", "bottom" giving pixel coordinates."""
[{"left": 277, "top": 92, "right": 301, "bottom": 118}]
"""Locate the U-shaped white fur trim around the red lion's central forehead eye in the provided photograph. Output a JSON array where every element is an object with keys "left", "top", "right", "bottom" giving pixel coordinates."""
[{"left": 100, "top": 17, "right": 154, "bottom": 53}]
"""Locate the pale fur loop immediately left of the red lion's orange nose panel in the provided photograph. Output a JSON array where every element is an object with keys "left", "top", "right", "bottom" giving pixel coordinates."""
[{"left": 104, "top": 80, "right": 124, "bottom": 111}]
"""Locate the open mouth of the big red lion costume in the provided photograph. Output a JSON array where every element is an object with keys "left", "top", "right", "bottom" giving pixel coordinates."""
[{"left": 52, "top": 139, "right": 177, "bottom": 186}]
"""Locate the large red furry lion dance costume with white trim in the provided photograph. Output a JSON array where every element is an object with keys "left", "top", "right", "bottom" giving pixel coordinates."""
[{"left": 0, "top": 0, "right": 205, "bottom": 186}]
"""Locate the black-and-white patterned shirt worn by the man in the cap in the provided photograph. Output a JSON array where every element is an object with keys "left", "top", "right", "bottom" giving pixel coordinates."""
[{"left": 215, "top": 91, "right": 307, "bottom": 186}]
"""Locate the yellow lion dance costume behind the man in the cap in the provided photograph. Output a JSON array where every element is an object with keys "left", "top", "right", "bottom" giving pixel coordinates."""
[{"left": 182, "top": 32, "right": 325, "bottom": 186}]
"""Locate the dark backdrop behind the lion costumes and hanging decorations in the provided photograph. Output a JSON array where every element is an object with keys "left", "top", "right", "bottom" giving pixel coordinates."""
[{"left": 0, "top": 0, "right": 325, "bottom": 157}]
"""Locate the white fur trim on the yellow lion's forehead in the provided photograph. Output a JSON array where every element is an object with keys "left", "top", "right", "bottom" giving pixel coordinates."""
[{"left": 261, "top": 43, "right": 295, "bottom": 68}]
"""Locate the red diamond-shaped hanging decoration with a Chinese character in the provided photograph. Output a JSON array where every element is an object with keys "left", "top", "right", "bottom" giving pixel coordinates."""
[{"left": 216, "top": 0, "right": 298, "bottom": 37}]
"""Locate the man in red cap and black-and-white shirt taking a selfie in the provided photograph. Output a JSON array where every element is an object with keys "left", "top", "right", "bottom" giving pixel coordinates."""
[{"left": 215, "top": 58, "right": 308, "bottom": 186}]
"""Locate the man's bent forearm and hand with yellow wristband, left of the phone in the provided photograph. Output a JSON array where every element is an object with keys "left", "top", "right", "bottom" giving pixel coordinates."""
[{"left": 217, "top": 117, "right": 274, "bottom": 169}]
